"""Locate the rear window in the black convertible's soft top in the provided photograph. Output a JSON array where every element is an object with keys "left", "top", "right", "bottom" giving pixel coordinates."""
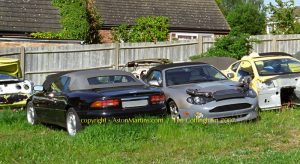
[{"left": 88, "top": 75, "right": 135, "bottom": 85}]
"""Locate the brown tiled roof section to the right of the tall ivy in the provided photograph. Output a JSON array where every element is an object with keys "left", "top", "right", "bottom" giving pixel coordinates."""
[{"left": 96, "top": 0, "right": 230, "bottom": 32}]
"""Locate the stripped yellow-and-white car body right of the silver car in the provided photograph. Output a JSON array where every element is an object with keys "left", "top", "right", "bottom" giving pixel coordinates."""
[{"left": 223, "top": 52, "right": 300, "bottom": 110}]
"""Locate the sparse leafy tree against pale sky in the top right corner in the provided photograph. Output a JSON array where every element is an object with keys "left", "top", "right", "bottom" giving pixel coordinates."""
[{"left": 266, "top": 0, "right": 299, "bottom": 34}]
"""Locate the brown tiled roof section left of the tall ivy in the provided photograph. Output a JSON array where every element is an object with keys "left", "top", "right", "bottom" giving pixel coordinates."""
[{"left": 0, "top": 0, "right": 61, "bottom": 32}]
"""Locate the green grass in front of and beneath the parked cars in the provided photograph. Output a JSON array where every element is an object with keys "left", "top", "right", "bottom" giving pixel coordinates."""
[{"left": 0, "top": 109, "right": 300, "bottom": 163}]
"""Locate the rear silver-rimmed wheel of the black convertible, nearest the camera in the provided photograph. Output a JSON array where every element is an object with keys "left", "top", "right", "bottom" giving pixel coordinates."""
[{"left": 66, "top": 108, "right": 82, "bottom": 136}]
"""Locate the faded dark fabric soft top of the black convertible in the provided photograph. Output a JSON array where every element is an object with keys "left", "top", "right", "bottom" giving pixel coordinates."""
[{"left": 43, "top": 69, "right": 144, "bottom": 90}]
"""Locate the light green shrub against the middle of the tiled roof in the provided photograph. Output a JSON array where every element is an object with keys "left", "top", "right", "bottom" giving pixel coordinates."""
[{"left": 113, "top": 16, "right": 170, "bottom": 42}]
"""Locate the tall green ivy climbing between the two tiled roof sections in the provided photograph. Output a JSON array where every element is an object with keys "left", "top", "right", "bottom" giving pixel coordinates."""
[{"left": 31, "top": 0, "right": 101, "bottom": 43}]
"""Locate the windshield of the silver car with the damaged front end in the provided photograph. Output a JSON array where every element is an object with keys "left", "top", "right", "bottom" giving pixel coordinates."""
[{"left": 165, "top": 65, "right": 227, "bottom": 86}]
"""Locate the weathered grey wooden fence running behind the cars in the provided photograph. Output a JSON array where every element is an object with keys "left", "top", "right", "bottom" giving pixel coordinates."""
[{"left": 0, "top": 35, "right": 300, "bottom": 84}]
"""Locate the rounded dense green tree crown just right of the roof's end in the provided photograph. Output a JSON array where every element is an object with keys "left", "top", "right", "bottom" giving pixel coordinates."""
[{"left": 226, "top": 3, "right": 266, "bottom": 35}]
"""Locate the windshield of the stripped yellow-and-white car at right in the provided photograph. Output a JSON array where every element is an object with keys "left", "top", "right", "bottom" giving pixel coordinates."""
[{"left": 255, "top": 58, "right": 300, "bottom": 76}]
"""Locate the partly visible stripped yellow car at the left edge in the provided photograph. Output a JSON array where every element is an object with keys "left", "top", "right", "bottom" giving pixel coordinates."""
[{"left": 0, "top": 58, "right": 32, "bottom": 109}]
